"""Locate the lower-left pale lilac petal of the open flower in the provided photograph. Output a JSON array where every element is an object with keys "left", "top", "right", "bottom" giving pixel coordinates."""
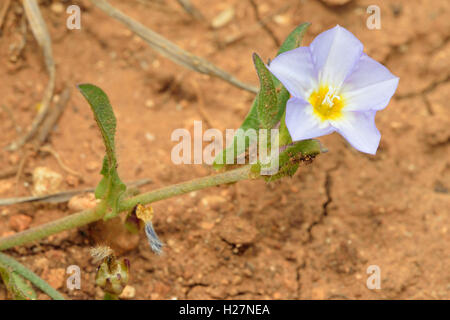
[{"left": 286, "top": 97, "right": 334, "bottom": 141}]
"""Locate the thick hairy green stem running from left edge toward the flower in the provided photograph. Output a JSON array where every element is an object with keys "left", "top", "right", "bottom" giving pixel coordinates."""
[{"left": 0, "top": 165, "right": 254, "bottom": 251}]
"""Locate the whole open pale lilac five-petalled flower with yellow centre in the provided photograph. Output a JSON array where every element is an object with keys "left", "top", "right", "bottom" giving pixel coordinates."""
[{"left": 267, "top": 25, "right": 399, "bottom": 154}]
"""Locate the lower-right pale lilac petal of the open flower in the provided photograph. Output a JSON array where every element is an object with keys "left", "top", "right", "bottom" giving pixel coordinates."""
[{"left": 331, "top": 110, "right": 381, "bottom": 154}]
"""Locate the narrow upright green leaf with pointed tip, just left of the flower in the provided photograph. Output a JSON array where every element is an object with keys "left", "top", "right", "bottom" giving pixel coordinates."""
[{"left": 253, "top": 53, "right": 279, "bottom": 129}]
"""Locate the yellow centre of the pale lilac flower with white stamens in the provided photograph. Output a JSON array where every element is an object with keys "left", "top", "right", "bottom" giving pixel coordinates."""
[{"left": 309, "top": 85, "right": 344, "bottom": 121}]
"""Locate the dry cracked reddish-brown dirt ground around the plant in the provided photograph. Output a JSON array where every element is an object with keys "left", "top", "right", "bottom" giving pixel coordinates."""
[{"left": 0, "top": 0, "right": 450, "bottom": 299}]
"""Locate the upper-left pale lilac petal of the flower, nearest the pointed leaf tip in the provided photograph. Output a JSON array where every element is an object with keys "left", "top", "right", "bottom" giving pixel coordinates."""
[{"left": 267, "top": 47, "right": 317, "bottom": 99}]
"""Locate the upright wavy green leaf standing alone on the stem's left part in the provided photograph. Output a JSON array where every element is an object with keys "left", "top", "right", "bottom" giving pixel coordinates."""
[{"left": 78, "top": 84, "right": 126, "bottom": 219}]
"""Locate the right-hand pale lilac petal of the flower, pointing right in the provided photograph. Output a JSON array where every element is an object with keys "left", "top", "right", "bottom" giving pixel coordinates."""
[{"left": 341, "top": 54, "right": 399, "bottom": 111}]
